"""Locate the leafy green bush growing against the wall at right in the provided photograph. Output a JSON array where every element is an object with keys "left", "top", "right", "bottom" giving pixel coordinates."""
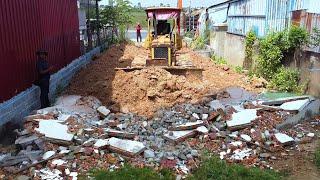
[{"left": 254, "top": 26, "right": 308, "bottom": 92}]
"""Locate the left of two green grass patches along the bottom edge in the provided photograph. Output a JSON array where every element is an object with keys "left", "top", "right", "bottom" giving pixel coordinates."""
[{"left": 90, "top": 164, "right": 175, "bottom": 180}]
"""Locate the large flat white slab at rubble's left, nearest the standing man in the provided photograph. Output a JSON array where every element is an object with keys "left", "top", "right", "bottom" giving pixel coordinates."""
[{"left": 35, "top": 120, "right": 73, "bottom": 142}]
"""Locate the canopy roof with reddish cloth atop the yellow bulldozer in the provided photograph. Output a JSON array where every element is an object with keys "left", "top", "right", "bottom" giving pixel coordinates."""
[{"left": 146, "top": 7, "right": 181, "bottom": 20}]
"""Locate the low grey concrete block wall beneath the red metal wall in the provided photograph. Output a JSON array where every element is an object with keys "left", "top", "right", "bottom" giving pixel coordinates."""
[{"left": 0, "top": 47, "right": 104, "bottom": 128}]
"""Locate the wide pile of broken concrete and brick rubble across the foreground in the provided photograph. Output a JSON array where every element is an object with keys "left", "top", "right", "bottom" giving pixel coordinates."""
[{"left": 0, "top": 88, "right": 320, "bottom": 179}]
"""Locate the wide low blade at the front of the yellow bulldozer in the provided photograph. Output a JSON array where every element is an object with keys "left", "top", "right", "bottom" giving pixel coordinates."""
[{"left": 115, "top": 66, "right": 204, "bottom": 80}]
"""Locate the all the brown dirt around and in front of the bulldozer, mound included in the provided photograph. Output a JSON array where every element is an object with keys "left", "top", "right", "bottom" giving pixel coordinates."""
[{"left": 65, "top": 44, "right": 261, "bottom": 117}]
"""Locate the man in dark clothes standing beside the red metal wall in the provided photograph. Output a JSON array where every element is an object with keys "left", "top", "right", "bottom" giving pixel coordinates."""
[{"left": 36, "top": 50, "right": 53, "bottom": 108}]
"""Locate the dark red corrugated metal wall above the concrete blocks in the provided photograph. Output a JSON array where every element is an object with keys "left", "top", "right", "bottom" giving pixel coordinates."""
[{"left": 0, "top": 0, "right": 80, "bottom": 103}]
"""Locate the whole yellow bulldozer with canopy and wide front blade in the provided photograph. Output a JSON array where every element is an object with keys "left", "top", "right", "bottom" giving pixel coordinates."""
[{"left": 117, "top": 7, "right": 203, "bottom": 78}]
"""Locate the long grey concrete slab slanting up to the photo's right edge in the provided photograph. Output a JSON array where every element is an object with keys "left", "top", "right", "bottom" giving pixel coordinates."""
[{"left": 277, "top": 99, "right": 320, "bottom": 129}]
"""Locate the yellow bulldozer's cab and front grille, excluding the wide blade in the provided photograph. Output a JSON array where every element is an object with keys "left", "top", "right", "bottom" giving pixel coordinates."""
[{"left": 144, "top": 7, "right": 182, "bottom": 66}]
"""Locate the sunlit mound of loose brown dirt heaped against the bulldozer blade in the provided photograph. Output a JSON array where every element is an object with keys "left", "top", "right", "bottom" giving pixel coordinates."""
[{"left": 112, "top": 68, "right": 204, "bottom": 116}]
